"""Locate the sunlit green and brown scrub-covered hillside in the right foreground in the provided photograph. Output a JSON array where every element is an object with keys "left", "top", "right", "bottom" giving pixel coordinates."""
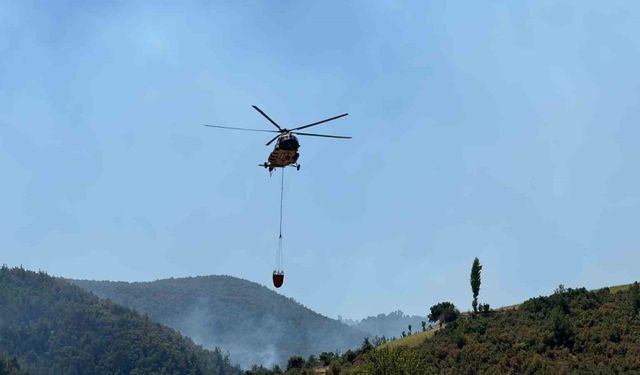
[{"left": 253, "top": 283, "right": 640, "bottom": 375}]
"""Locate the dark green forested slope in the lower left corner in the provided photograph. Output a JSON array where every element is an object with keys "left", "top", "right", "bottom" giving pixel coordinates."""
[{"left": 0, "top": 266, "right": 239, "bottom": 375}]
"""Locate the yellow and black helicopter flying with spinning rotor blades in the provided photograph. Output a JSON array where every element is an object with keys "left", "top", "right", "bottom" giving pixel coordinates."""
[{"left": 205, "top": 105, "right": 351, "bottom": 173}]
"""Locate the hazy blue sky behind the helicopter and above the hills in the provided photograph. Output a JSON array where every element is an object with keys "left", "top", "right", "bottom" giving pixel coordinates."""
[{"left": 0, "top": 0, "right": 640, "bottom": 318}]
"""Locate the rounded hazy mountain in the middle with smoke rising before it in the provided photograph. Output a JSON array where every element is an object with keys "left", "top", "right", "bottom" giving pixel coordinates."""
[{"left": 73, "top": 276, "right": 366, "bottom": 366}]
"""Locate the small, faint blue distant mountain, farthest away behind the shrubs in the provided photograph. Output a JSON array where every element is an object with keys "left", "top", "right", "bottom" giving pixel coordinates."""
[{"left": 344, "top": 310, "right": 427, "bottom": 338}]
